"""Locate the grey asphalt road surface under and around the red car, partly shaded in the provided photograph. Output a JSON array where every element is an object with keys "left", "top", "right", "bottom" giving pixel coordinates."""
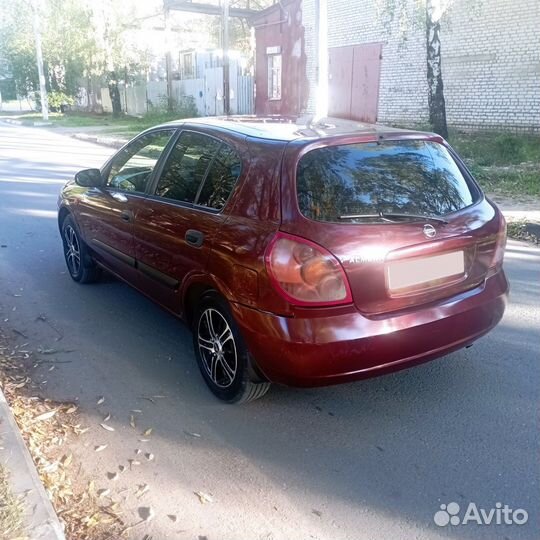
[{"left": 0, "top": 123, "right": 540, "bottom": 540}]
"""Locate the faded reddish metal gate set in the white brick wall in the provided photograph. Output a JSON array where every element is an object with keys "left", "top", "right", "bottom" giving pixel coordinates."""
[{"left": 328, "top": 43, "right": 382, "bottom": 122}]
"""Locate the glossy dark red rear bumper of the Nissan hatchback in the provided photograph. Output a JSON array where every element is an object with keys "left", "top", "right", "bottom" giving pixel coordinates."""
[{"left": 232, "top": 270, "right": 508, "bottom": 386}]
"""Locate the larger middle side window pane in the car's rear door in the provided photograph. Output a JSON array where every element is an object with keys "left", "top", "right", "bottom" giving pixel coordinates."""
[{"left": 156, "top": 131, "right": 220, "bottom": 203}]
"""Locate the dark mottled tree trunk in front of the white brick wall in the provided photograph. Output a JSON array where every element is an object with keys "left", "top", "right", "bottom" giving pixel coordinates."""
[{"left": 426, "top": 0, "right": 448, "bottom": 139}]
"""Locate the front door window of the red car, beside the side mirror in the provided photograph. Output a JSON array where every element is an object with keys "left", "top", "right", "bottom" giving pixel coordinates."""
[{"left": 107, "top": 129, "right": 174, "bottom": 193}]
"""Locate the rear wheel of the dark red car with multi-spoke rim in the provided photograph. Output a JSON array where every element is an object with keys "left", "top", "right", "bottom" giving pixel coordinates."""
[{"left": 193, "top": 294, "right": 270, "bottom": 403}]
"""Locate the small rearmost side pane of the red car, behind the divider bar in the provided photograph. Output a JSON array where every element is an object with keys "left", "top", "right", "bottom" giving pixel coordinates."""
[{"left": 196, "top": 144, "right": 242, "bottom": 210}]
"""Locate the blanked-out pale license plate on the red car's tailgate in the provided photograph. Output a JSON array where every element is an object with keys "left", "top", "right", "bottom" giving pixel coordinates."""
[{"left": 388, "top": 251, "right": 465, "bottom": 291}]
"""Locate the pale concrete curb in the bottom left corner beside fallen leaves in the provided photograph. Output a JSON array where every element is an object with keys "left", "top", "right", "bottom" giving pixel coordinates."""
[{"left": 0, "top": 389, "right": 66, "bottom": 540}]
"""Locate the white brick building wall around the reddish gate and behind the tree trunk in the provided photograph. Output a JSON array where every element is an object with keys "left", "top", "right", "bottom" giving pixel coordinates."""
[{"left": 284, "top": 0, "right": 540, "bottom": 130}]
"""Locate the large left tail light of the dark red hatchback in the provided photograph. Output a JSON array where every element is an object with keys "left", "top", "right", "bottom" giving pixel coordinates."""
[{"left": 266, "top": 232, "right": 352, "bottom": 306}]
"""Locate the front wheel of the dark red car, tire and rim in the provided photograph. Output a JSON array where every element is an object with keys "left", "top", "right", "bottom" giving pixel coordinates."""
[{"left": 62, "top": 216, "right": 101, "bottom": 283}]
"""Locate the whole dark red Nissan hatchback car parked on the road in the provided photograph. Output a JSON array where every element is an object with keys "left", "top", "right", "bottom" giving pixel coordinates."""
[{"left": 58, "top": 117, "right": 508, "bottom": 402}]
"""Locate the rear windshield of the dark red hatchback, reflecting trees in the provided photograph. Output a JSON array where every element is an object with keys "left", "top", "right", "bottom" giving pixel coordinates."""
[{"left": 296, "top": 140, "right": 474, "bottom": 221}]
